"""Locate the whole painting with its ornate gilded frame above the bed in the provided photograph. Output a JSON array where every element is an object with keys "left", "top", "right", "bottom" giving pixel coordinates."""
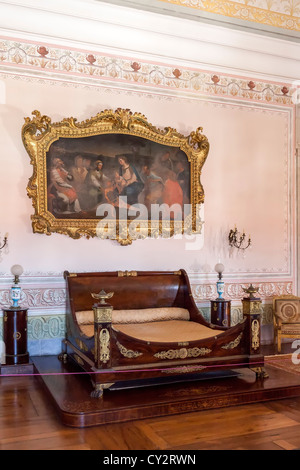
[{"left": 22, "top": 108, "right": 209, "bottom": 245}]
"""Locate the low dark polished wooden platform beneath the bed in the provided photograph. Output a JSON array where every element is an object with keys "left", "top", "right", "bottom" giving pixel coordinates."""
[{"left": 31, "top": 356, "right": 300, "bottom": 427}]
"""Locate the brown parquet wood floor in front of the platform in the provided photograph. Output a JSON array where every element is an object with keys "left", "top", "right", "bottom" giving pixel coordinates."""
[{"left": 0, "top": 346, "right": 300, "bottom": 451}]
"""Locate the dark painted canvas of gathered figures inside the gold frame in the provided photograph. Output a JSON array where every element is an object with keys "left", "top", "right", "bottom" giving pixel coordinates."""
[{"left": 47, "top": 134, "right": 190, "bottom": 218}]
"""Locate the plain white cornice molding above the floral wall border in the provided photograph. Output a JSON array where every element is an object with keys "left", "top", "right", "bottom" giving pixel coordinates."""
[{"left": 0, "top": 0, "right": 300, "bottom": 82}]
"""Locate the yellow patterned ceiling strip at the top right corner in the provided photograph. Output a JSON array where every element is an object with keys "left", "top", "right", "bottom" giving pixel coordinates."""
[{"left": 159, "top": 0, "right": 300, "bottom": 31}]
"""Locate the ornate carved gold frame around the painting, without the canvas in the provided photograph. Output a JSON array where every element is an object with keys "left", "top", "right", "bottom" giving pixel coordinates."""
[{"left": 22, "top": 108, "right": 209, "bottom": 245}]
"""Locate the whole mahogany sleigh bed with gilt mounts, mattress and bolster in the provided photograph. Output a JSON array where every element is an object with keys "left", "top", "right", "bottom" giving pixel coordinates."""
[{"left": 60, "top": 270, "right": 267, "bottom": 397}]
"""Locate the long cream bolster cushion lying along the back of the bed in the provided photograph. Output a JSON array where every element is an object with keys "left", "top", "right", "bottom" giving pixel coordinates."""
[{"left": 76, "top": 307, "right": 190, "bottom": 325}]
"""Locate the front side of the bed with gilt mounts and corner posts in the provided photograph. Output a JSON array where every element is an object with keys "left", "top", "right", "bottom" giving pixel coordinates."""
[{"left": 88, "top": 292, "right": 268, "bottom": 398}]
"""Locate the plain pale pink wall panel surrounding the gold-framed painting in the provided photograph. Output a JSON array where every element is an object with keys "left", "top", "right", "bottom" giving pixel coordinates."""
[{"left": 0, "top": 78, "right": 295, "bottom": 281}]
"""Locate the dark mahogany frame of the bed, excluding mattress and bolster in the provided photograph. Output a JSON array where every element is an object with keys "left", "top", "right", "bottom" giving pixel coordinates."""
[{"left": 64, "top": 269, "right": 266, "bottom": 396}]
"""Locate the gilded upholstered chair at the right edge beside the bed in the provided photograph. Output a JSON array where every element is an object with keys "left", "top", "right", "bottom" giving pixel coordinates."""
[{"left": 273, "top": 295, "right": 300, "bottom": 352}]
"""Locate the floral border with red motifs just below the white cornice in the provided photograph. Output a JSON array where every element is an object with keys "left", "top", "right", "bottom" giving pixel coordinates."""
[{"left": 0, "top": 37, "right": 295, "bottom": 106}]
